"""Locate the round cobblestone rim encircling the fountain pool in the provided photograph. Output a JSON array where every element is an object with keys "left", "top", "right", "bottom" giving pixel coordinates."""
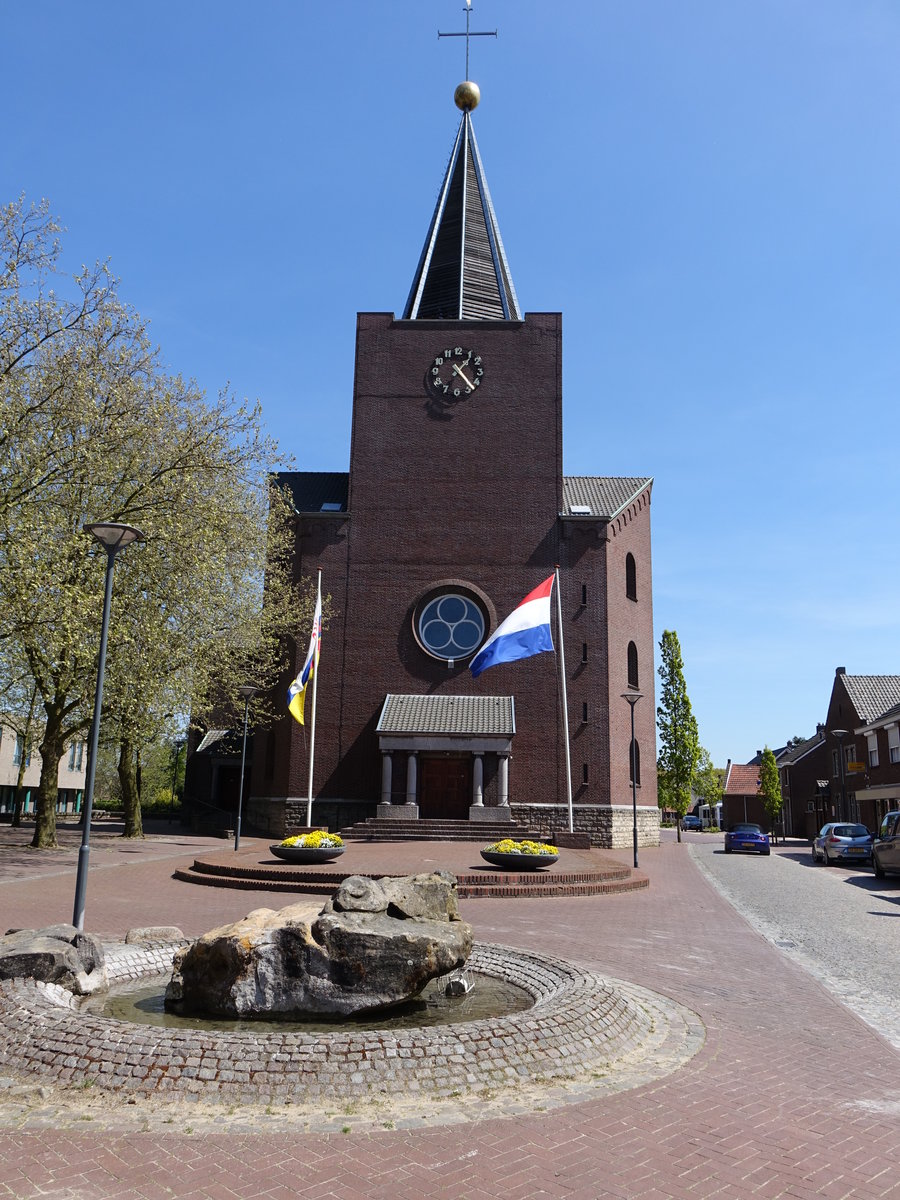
[{"left": 0, "top": 943, "right": 704, "bottom": 1127}]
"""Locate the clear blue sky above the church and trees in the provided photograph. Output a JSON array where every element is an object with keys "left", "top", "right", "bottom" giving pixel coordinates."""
[{"left": 0, "top": 0, "right": 900, "bottom": 764}]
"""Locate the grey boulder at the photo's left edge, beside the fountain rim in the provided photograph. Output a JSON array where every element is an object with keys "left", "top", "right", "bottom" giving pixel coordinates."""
[{"left": 0, "top": 925, "right": 109, "bottom": 996}]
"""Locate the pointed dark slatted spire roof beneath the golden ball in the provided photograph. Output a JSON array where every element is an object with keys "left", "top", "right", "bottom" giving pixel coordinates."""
[{"left": 403, "top": 113, "right": 522, "bottom": 320}]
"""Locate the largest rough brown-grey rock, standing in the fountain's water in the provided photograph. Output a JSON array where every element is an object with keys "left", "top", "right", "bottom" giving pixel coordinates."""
[{"left": 166, "top": 871, "right": 472, "bottom": 1019}]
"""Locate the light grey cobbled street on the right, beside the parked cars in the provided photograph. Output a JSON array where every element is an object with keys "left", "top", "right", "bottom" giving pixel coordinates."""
[{"left": 685, "top": 834, "right": 900, "bottom": 1049}]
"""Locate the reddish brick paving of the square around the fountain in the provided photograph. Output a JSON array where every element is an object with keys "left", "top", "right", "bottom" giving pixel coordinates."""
[{"left": 0, "top": 830, "right": 900, "bottom": 1200}]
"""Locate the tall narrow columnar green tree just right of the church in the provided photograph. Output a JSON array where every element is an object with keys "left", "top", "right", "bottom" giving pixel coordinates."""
[{"left": 656, "top": 630, "right": 700, "bottom": 841}]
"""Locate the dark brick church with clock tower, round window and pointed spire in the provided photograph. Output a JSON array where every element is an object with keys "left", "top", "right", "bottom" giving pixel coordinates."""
[{"left": 246, "top": 75, "right": 659, "bottom": 846}]
